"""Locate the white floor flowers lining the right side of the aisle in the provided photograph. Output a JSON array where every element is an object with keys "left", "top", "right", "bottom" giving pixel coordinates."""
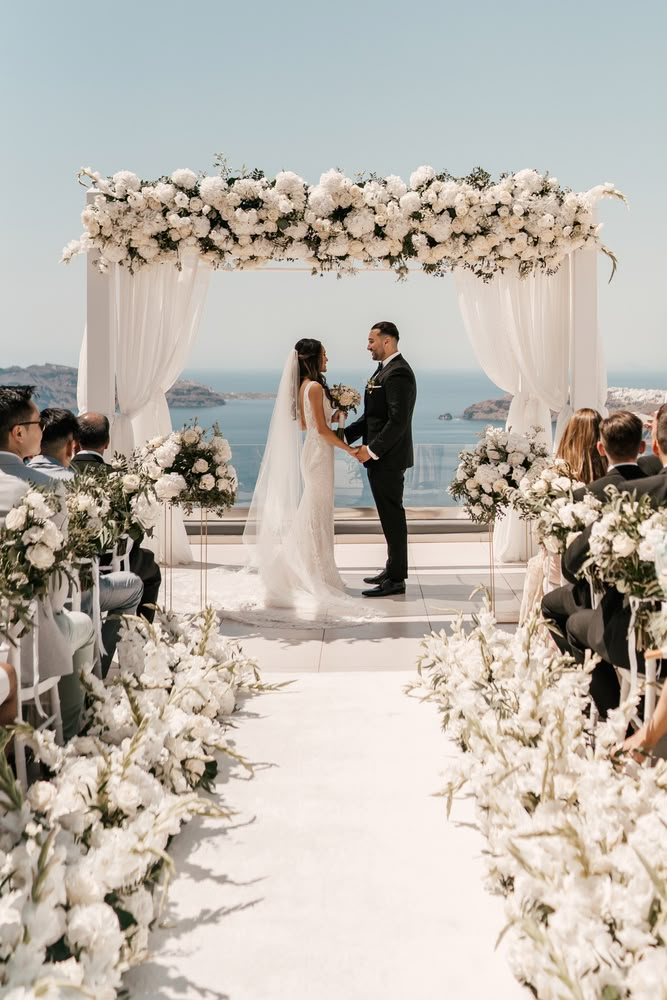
[{"left": 418, "top": 613, "right": 667, "bottom": 1000}]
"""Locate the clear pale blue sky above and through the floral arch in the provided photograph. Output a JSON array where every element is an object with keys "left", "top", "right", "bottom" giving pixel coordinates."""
[{"left": 0, "top": 0, "right": 667, "bottom": 370}]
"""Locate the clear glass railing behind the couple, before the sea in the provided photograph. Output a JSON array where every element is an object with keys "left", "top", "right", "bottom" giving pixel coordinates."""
[{"left": 232, "top": 443, "right": 461, "bottom": 507}]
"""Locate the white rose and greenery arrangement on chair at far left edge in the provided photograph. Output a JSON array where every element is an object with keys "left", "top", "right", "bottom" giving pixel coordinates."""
[{"left": 0, "top": 487, "right": 72, "bottom": 636}]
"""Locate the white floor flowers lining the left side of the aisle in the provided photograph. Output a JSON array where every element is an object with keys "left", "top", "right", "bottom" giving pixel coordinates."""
[{"left": 0, "top": 609, "right": 259, "bottom": 1000}]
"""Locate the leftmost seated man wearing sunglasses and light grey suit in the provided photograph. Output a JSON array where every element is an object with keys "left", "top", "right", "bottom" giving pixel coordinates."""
[{"left": 0, "top": 386, "right": 95, "bottom": 739}]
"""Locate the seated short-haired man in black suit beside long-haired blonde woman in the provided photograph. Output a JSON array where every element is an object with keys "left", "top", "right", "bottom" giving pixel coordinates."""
[{"left": 542, "top": 410, "right": 646, "bottom": 718}]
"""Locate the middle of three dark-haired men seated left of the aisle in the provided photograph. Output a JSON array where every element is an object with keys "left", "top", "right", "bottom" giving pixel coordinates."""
[{"left": 28, "top": 409, "right": 144, "bottom": 677}]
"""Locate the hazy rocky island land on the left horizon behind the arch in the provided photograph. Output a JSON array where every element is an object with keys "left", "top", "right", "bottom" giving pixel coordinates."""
[{"left": 0, "top": 364, "right": 275, "bottom": 411}]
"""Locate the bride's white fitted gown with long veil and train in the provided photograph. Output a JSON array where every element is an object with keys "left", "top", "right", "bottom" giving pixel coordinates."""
[{"left": 176, "top": 352, "right": 379, "bottom": 628}]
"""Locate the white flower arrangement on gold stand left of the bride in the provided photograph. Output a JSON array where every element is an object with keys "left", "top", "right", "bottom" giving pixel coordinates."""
[{"left": 134, "top": 420, "right": 238, "bottom": 514}]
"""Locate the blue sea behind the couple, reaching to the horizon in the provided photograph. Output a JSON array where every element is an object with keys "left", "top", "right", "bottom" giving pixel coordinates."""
[{"left": 170, "top": 364, "right": 667, "bottom": 507}]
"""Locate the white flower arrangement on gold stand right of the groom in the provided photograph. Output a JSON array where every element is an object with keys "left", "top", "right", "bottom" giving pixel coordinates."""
[{"left": 449, "top": 426, "right": 547, "bottom": 524}]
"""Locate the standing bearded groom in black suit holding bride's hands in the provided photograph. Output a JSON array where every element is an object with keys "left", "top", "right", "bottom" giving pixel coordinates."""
[{"left": 345, "top": 322, "right": 417, "bottom": 597}]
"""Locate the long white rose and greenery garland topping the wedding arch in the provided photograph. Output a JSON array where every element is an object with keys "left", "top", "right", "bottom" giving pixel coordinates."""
[{"left": 63, "top": 157, "right": 623, "bottom": 280}]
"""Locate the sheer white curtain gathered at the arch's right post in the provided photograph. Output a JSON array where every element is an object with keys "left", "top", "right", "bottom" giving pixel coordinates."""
[{"left": 454, "top": 266, "right": 571, "bottom": 562}]
